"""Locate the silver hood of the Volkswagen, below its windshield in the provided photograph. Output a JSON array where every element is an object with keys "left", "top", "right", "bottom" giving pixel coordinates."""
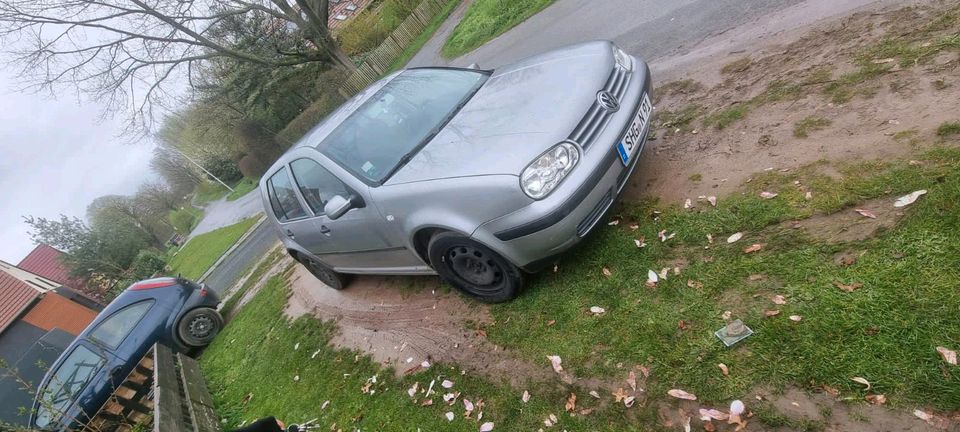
[{"left": 386, "top": 42, "right": 614, "bottom": 185}]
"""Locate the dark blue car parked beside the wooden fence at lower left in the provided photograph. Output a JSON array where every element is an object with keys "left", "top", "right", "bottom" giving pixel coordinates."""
[{"left": 30, "top": 278, "right": 223, "bottom": 431}]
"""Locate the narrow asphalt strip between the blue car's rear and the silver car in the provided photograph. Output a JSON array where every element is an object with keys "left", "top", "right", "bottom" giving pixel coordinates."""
[{"left": 203, "top": 222, "right": 280, "bottom": 294}]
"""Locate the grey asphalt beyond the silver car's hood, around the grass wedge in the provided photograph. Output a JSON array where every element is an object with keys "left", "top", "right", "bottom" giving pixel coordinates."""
[{"left": 408, "top": 0, "right": 802, "bottom": 68}]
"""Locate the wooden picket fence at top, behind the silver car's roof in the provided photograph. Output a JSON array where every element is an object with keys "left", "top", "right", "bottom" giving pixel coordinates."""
[{"left": 340, "top": 0, "right": 452, "bottom": 98}]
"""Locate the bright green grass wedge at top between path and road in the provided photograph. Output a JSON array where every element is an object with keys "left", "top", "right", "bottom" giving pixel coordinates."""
[{"left": 440, "top": 0, "right": 556, "bottom": 58}]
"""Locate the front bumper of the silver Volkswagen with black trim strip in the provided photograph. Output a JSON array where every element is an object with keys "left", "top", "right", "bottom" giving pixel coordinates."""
[{"left": 473, "top": 59, "right": 651, "bottom": 272}]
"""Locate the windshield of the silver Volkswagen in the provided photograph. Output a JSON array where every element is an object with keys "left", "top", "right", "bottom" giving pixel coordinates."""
[{"left": 318, "top": 69, "right": 487, "bottom": 184}]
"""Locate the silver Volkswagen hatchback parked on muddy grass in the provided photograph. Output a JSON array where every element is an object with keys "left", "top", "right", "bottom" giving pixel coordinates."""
[{"left": 260, "top": 41, "right": 653, "bottom": 302}]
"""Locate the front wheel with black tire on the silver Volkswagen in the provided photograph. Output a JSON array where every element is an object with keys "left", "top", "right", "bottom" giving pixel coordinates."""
[{"left": 427, "top": 232, "right": 523, "bottom": 303}]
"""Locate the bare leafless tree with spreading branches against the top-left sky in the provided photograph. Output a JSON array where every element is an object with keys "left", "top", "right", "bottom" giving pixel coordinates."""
[{"left": 0, "top": 0, "right": 355, "bottom": 125}]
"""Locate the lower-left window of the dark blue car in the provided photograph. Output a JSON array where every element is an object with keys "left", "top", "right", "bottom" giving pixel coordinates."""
[{"left": 34, "top": 345, "right": 105, "bottom": 428}]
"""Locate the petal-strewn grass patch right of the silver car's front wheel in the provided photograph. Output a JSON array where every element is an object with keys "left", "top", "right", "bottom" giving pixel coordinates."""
[{"left": 487, "top": 149, "right": 960, "bottom": 409}]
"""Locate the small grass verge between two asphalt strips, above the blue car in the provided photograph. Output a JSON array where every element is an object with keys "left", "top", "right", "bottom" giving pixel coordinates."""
[{"left": 168, "top": 218, "right": 257, "bottom": 280}]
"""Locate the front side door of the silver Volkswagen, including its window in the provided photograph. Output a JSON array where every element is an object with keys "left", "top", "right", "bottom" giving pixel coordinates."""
[{"left": 290, "top": 156, "right": 422, "bottom": 272}]
